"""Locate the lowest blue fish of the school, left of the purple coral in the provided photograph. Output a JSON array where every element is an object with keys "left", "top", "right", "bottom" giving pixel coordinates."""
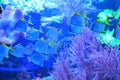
[{"left": 28, "top": 52, "right": 45, "bottom": 66}]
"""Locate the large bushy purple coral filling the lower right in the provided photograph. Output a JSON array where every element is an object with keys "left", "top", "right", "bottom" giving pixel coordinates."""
[{"left": 53, "top": 27, "right": 120, "bottom": 80}]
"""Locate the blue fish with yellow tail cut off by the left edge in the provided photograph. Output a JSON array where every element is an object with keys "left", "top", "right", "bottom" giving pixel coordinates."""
[{"left": 0, "top": 43, "right": 10, "bottom": 58}]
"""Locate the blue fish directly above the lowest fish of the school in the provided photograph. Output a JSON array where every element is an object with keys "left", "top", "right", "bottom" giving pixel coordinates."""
[{"left": 34, "top": 40, "right": 48, "bottom": 54}]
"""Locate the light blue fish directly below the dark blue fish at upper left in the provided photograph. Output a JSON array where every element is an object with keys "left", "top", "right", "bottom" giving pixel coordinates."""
[{"left": 25, "top": 28, "right": 40, "bottom": 41}]
